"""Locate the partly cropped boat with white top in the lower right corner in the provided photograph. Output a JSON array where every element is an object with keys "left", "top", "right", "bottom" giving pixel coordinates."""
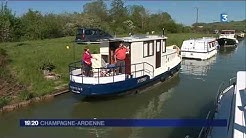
[{"left": 199, "top": 71, "right": 246, "bottom": 138}]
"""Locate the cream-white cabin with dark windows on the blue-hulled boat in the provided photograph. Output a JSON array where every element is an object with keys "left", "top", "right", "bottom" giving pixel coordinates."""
[{"left": 100, "top": 36, "right": 172, "bottom": 77}]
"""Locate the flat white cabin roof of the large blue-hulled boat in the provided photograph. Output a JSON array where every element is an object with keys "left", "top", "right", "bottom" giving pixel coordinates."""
[{"left": 109, "top": 35, "right": 167, "bottom": 42}]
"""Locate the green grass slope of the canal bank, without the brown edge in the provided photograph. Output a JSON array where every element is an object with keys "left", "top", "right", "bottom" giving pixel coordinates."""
[{"left": 0, "top": 34, "right": 215, "bottom": 104}]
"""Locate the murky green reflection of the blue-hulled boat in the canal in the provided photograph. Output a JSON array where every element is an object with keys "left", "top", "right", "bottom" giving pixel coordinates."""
[{"left": 71, "top": 74, "right": 180, "bottom": 138}]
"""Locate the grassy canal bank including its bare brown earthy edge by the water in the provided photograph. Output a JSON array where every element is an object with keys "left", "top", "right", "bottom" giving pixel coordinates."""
[{"left": 0, "top": 33, "right": 214, "bottom": 112}]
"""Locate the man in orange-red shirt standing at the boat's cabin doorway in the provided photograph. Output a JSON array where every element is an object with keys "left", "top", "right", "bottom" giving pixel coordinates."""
[{"left": 114, "top": 43, "right": 129, "bottom": 74}]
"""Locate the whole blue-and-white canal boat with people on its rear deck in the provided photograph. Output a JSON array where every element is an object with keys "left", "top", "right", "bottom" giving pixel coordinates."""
[{"left": 69, "top": 35, "right": 182, "bottom": 97}]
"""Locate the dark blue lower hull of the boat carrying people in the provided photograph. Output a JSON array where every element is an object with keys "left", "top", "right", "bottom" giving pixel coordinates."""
[{"left": 69, "top": 62, "right": 181, "bottom": 97}]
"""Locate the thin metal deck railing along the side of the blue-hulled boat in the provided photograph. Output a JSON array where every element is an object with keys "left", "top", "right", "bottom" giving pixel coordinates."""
[{"left": 69, "top": 61, "right": 154, "bottom": 84}]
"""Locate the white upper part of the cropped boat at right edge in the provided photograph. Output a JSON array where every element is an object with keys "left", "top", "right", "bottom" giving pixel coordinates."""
[{"left": 234, "top": 71, "right": 246, "bottom": 138}]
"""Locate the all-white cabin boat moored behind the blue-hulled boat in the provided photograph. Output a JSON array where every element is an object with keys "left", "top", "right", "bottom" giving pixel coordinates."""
[{"left": 181, "top": 37, "right": 219, "bottom": 60}]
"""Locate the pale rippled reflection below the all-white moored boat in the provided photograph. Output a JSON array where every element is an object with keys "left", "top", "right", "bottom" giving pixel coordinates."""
[{"left": 181, "top": 56, "right": 216, "bottom": 76}]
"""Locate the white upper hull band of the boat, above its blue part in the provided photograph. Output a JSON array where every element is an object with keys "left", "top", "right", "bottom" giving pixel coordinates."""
[{"left": 70, "top": 47, "right": 181, "bottom": 85}]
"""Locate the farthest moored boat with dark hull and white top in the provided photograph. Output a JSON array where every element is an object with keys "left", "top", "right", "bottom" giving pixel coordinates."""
[{"left": 217, "top": 30, "right": 238, "bottom": 48}]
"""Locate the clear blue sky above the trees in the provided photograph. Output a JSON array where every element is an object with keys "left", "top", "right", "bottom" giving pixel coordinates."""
[{"left": 5, "top": 0, "right": 246, "bottom": 25}]
